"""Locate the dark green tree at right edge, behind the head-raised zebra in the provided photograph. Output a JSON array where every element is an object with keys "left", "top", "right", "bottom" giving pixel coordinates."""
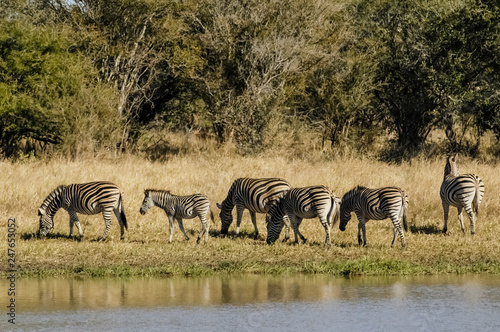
[{"left": 427, "top": 1, "right": 500, "bottom": 154}]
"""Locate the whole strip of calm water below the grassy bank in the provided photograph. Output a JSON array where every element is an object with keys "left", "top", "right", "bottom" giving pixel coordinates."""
[{"left": 0, "top": 275, "right": 500, "bottom": 331}]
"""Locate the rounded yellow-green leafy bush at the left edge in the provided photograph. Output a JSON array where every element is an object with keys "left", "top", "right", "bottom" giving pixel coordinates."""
[{"left": 0, "top": 21, "right": 120, "bottom": 158}]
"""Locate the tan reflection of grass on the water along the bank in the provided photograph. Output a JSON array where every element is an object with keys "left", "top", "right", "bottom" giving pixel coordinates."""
[{"left": 0, "top": 275, "right": 500, "bottom": 311}]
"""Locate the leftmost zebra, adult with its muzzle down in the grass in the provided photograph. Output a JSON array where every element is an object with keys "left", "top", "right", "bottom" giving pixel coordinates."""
[{"left": 38, "top": 181, "right": 127, "bottom": 240}]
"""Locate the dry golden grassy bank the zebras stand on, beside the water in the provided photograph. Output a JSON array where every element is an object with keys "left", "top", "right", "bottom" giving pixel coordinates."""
[{"left": 0, "top": 153, "right": 500, "bottom": 277}]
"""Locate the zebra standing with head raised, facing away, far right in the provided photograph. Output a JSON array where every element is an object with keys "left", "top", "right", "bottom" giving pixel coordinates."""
[{"left": 439, "top": 155, "right": 484, "bottom": 235}]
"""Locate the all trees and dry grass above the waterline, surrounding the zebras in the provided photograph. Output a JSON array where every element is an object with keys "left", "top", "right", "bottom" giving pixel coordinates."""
[{"left": 0, "top": 0, "right": 500, "bottom": 276}]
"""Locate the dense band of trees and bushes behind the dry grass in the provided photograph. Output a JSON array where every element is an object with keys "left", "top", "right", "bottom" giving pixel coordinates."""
[{"left": 0, "top": 0, "right": 500, "bottom": 160}]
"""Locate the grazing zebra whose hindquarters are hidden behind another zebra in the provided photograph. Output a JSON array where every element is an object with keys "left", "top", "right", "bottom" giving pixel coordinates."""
[{"left": 217, "top": 178, "right": 290, "bottom": 239}]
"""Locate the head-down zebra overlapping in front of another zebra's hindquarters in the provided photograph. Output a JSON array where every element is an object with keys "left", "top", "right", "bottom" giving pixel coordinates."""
[{"left": 266, "top": 186, "right": 340, "bottom": 247}]
